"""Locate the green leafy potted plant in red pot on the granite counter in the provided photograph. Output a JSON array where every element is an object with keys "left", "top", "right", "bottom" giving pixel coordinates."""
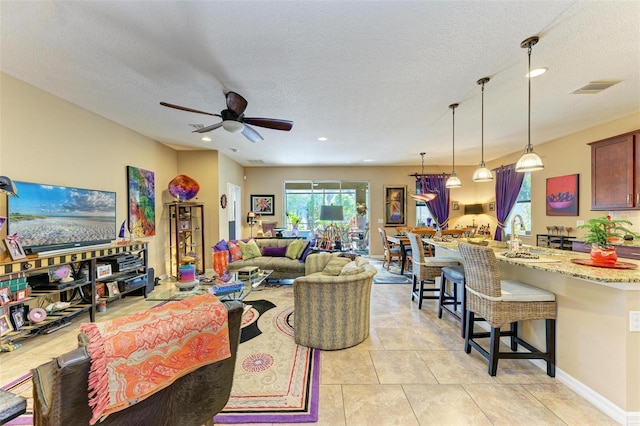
[{"left": 578, "top": 216, "right": 639, "bottom": 264}]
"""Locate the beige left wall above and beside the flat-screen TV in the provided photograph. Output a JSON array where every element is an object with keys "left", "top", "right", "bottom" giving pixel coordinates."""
[{"left": 0, "top": 73, "right": 177, "bottom": 275}]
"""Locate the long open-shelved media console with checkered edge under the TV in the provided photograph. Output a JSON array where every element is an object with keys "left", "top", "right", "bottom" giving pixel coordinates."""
[{"left": 0, "top": 242, "right": 149, "bottom": 344}]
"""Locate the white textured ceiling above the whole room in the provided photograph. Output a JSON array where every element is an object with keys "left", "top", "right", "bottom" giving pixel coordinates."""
[{"left": 0, "top": 0, "right": 640, "bottom": 169}]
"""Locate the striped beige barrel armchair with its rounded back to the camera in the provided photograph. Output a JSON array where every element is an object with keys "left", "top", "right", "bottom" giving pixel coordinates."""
[{"left": 293, "top": 253, "right": 376, "bottom": 350}]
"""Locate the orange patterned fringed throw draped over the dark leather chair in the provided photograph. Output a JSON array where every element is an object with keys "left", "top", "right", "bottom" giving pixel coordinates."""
[{"left": 80, "top": 294, "right": 231, "bottom": 425}]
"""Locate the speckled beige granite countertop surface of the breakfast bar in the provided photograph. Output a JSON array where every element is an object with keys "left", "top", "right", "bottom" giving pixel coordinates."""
[{"left": 428, "top": 240, "right": 640, "bottom": 290}]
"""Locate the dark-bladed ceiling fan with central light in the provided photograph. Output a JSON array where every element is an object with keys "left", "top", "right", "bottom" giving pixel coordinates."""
[{"left": 160, "top": 92, "right": 293, "bottom": 142}]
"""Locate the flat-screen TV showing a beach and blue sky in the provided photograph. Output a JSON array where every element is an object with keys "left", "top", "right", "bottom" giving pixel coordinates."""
[{"left": 7, "top": 181, "right": 116, "bottom": 253}]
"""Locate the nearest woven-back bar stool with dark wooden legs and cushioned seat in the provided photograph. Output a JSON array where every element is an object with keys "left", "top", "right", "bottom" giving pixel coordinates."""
[{"left": 458, "top": 242, "right": 558, "bottom": 377}]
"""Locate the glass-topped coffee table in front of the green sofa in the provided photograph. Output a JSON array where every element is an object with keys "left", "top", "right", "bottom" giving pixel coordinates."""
[{"left": 146, "top": 270, "right": 273, "bottom": 302}]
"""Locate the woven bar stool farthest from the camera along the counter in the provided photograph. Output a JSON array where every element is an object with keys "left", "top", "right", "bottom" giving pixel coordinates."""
[{"left": 408, "top": 232, "right": 460, "bottom": 309}]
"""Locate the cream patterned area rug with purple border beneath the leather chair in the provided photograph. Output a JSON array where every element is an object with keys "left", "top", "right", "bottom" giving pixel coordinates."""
[{"left": 2, "top": 286, "right": 320, "bottom": 425}]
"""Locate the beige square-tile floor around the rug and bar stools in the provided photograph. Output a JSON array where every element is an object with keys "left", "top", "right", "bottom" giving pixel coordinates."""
[{"left": 0, "top": 274, "right": 616, "bottom": 426}]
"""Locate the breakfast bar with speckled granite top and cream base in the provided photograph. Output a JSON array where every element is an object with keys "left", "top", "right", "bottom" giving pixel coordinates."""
[{"left": 429, "top": 239, "right": 640, "bottom": 424}]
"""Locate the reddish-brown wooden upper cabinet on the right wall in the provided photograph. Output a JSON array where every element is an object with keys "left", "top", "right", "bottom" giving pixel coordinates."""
[{"left": 590, "top": 131, "right": 640, "bottom": 210}]
